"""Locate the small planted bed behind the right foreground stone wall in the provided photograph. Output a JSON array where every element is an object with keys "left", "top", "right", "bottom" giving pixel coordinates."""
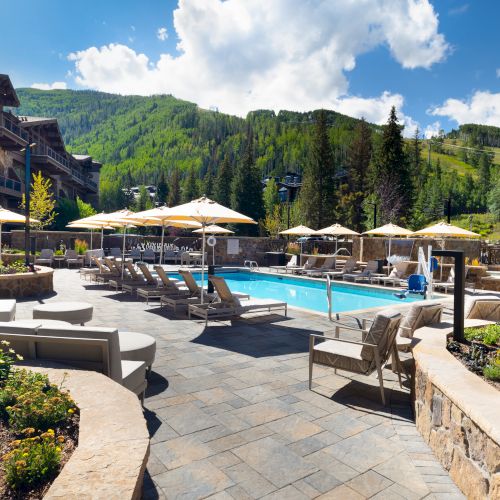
[{"left": 447, "top": 324, "right": 500, "bottom": 390}]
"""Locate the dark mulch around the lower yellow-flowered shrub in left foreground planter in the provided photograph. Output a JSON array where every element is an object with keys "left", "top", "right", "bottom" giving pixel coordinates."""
[{"left": 0, "top": 413, "right": 80, "bottom": 500}]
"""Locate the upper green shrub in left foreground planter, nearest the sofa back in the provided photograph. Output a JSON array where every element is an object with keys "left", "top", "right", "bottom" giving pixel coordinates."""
[{"left": 0, "top": 370, "right": 76, "bottom": 432}]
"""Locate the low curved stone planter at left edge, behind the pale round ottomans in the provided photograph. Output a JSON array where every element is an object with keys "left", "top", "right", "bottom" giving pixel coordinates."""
[{"left": 0, "top": 266, "right": 54, "bottom": 299}]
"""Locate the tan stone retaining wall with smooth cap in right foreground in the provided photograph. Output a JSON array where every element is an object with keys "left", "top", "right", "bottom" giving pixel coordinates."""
[{"left": 413, "top": 320, "right": 500, "bottom": 500}]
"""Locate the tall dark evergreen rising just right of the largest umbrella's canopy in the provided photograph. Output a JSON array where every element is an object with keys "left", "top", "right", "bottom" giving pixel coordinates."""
[{"left": 231, "top": 130, "right": 265, "bottom": 236}]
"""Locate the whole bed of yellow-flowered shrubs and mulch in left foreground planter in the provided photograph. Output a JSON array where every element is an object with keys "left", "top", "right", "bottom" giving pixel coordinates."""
[{"left": 0, "top": 341, "right": 79, "bottom": 499}]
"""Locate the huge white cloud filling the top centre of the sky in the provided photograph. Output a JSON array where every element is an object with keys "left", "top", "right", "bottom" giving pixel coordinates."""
[{"left": 69, "top": 0, "right": 449, "bottom": 122}]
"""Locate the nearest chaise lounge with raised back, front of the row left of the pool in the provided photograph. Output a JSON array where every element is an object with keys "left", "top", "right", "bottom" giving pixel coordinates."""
[{"left": 188, "top": 276, "right": 288, "bottom": 325}]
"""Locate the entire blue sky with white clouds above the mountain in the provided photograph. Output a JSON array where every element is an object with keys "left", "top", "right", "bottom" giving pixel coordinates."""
[{"left": 0, "top": 0, "right": 500, "bottom": 134}]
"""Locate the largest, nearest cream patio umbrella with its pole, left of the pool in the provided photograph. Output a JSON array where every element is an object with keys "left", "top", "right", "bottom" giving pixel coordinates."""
[{"left": 165, "top": 196, "right": 257, "bottom": 304}]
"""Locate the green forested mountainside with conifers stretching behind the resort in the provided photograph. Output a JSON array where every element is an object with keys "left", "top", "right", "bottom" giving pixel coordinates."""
[{"left": 13, "top": 89, "right": 500, "bottom": 234}]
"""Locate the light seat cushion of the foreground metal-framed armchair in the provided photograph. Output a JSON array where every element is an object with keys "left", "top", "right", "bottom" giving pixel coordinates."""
[{"left": 313, "top": 340, "right": 371, "bottom": 373}]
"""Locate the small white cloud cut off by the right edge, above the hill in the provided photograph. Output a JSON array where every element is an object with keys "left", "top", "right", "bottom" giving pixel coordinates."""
[{"left": 427, "top": 90, "right": 500, "bottom": 127}]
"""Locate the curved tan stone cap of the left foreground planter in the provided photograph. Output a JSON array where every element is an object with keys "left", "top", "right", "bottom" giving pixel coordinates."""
[{"left": 27, "top": 364, "right": 149, "bottom": 500}]
